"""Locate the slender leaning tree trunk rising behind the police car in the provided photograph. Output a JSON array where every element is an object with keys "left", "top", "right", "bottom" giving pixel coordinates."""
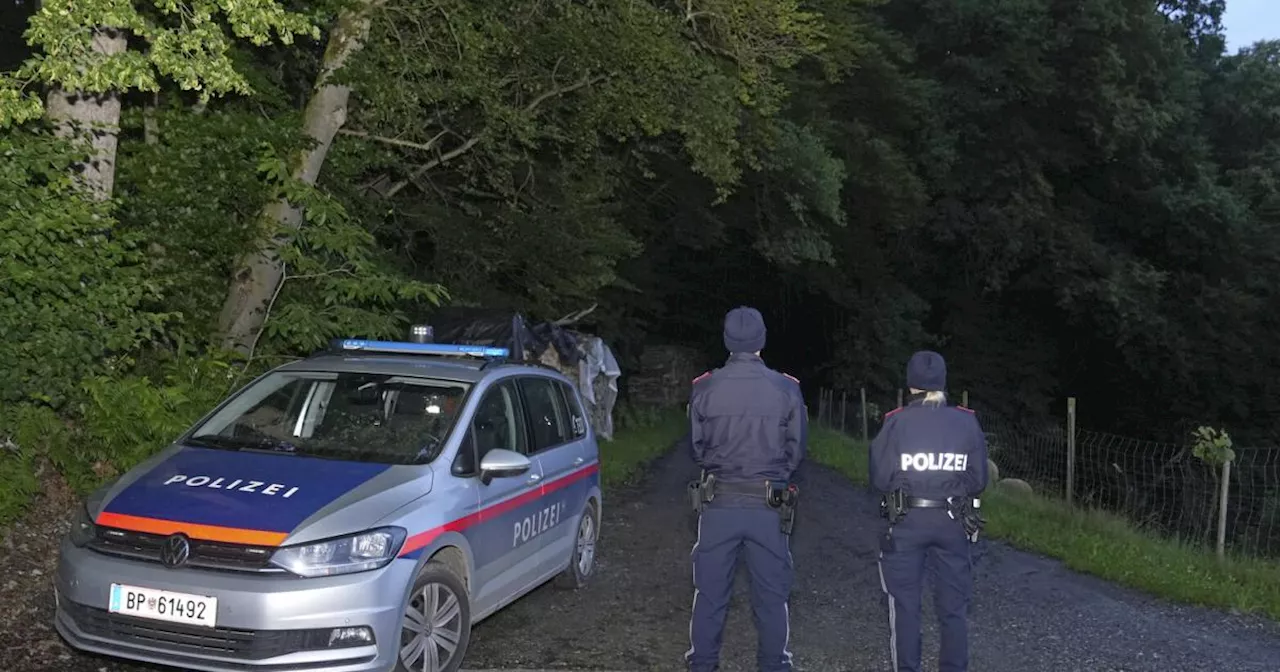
[{"left": 219, "top": 6, "right": 378, "bottom": 353}]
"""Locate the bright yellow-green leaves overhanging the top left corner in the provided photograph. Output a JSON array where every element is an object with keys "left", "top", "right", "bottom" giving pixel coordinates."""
[{"left": 0, "top": 0, "right": 320, "bottom": 128}]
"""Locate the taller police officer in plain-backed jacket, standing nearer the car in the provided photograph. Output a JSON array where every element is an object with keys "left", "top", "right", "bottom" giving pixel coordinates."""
[{"left": 685, "top": 306, "right": 808, "bottom": 672}]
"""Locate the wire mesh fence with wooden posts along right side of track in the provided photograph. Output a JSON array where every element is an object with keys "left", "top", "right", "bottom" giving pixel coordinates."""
[{"left": 815, "top": 389, "right": 1280, "bottom": 558}]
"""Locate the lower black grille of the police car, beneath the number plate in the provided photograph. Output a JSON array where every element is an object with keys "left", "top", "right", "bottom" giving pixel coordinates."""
[{"left": 60, "top": 600, "right": 368, "bottom": 660}]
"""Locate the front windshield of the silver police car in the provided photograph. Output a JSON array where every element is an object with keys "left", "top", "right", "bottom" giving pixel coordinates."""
[{"left": 186, "top": 371, "right": 467, "bottom": 465}]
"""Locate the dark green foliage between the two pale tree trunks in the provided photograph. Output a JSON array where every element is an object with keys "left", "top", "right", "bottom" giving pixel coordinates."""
[{"left": 115, "top": 105, "right": 298, "bottom": 343}]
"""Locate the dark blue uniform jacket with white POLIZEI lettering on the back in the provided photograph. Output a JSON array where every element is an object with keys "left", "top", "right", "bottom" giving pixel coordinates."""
[{"left": 868, "top": 399, "right": 987, "bottom": 499}]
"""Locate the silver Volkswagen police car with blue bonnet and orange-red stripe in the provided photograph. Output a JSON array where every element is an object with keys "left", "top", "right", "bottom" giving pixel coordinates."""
[{"left": 55, "top": 340, "right": 602, "bottom": 672}]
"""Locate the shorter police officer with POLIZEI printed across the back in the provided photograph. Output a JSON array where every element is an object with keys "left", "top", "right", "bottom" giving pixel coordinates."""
[{"left": 868, "top": 351, "right": 987, "bottom": 672}]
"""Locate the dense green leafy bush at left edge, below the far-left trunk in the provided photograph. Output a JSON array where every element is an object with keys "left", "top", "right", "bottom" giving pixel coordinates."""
[{"left": 0, "top": 131, "right": 166, "bottom": 406}]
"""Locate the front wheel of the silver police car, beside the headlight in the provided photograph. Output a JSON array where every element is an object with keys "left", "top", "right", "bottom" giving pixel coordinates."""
[{"left": 396, "top": 562, "right": 471, "bottom": 672}]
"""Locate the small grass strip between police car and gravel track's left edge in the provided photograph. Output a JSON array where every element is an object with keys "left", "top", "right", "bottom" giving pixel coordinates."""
[{"left": 600, "top": 407, "right": 689, "bottom": 488}]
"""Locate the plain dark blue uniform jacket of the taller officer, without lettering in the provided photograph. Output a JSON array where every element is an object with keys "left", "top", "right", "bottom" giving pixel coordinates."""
[{"left": 689, "top": 353, "right": 809, "bottom": 483}]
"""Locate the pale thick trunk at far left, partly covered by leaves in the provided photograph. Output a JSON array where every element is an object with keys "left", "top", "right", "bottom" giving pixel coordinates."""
[{"left": 45, "top": 29, "right": 128, "bottom": 201}]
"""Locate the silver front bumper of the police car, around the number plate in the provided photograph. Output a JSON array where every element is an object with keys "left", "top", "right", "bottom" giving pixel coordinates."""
[{"left": 55, "top": 539, "right": 416, "bottom": 672}]
